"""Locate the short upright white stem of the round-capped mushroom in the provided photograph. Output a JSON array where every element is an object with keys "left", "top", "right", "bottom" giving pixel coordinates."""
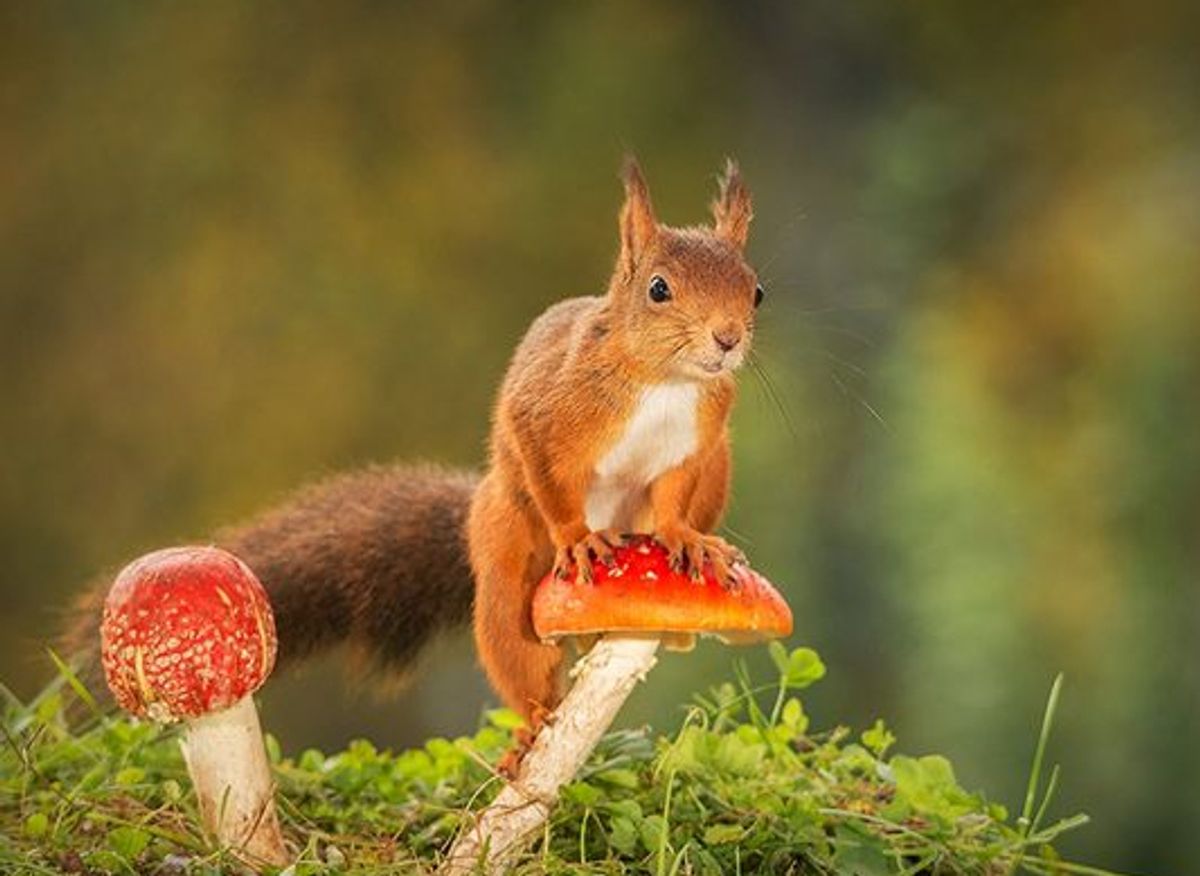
[{"left": 180, "top": 696, "right": 288, "bottom": 866}]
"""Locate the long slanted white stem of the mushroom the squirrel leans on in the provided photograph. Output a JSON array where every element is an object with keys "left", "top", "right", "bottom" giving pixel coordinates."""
[{"left": 439, "top": 637, "right": 659, "bottom": 876}]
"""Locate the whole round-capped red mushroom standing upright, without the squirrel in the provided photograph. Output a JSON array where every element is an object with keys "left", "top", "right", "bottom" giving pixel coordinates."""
[{"left": 101, "top": 547, "right": 288, "bottom": 866}]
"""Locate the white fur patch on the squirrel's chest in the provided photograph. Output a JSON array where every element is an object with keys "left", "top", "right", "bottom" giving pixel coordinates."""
[{"left": 584, "top": 383, "right": 700, "bottom": 529}]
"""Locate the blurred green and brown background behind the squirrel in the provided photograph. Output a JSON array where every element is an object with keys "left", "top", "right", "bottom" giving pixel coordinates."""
[{"left": 0, "top": 0, "right": 1200, "bottom": 874}]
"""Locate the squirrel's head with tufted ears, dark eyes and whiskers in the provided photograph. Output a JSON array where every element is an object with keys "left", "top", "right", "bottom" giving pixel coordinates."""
[{"left": 608, "top": 157, "right": 763, "bottom": 380}]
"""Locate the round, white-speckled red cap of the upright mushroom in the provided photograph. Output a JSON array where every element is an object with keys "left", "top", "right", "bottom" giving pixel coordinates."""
[{"left": 100, "top": 547, "right": 276, "bottom": 721}]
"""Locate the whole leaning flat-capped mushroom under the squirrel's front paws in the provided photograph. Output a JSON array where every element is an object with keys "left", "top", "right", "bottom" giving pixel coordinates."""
[{"left": 442, "top": 535, "right": 792, "bottom": 875}]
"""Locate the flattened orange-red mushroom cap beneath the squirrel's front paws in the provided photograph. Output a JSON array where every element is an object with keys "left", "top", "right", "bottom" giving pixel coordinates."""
[{"left": 533, "top": 535, "right": 792, "bottom": 644}]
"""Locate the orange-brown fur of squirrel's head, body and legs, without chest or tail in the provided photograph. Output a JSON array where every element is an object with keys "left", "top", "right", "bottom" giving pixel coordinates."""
[{"left": 468, "top": 162, "right": 756, "bottom": 716}]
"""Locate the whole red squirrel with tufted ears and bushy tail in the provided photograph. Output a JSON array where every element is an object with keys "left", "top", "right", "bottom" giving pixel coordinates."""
[{"left": 62, "top": 160, "right": 763, "bottom": 719}]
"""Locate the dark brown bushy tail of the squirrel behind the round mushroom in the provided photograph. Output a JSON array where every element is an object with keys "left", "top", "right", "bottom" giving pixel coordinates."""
[{"left": 59, "top": 466, "right": 478, "bottom": 692}]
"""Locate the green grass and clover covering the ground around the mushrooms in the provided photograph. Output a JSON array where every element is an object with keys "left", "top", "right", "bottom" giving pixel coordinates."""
[{"left": 0, "top": 646, "right": 1123, "bottom": 876}]
